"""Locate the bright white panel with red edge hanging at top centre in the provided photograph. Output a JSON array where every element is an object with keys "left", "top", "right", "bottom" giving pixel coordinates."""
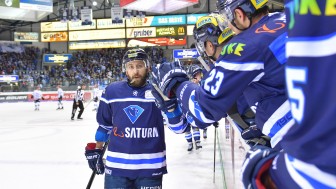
[{"left": 120, "top": 0, "right": 199, "bottom": 14}]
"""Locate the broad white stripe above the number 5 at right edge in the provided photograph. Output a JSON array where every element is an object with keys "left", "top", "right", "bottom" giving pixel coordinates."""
[{"left": 286, "top": 33, "right": 336, "bottom": 57}]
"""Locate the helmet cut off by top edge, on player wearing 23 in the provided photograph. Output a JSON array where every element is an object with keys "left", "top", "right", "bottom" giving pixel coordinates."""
[{"left": 216, "top": 0, "right": 268, "bottom": 23}]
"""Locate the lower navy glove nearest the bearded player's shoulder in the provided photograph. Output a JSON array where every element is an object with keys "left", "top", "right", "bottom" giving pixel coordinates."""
[{"left": 151, "top": 84, "right": 177, "bottom": 112}]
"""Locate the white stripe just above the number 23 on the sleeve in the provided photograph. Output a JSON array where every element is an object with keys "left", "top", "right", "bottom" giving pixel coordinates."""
[{"left": 215, "top": 61, "right": 264, "bottom": 71}]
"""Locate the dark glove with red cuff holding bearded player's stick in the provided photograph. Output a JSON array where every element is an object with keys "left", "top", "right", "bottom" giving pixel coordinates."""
[{"left": 85, "top": 143, "right": 105, "bottom": 175}]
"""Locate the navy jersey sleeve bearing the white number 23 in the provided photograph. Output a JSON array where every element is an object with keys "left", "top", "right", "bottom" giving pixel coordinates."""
[{"left": 176, "top": 44, "right": 264, "bottom": 124}]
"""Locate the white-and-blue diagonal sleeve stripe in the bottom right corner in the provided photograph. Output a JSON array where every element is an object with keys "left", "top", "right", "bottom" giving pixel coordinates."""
[{"left": 285, "top": 154, "right": 336, "bottom": 189}]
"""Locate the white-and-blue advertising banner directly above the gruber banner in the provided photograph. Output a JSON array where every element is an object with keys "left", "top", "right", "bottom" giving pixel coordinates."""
[{"left": 126, "top": 15, "right": 186, "bottom": 28}]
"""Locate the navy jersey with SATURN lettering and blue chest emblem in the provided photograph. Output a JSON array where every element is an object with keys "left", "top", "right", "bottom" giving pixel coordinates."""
[{"left": 96, "top": 81, "right": 167, "bottom": 178}]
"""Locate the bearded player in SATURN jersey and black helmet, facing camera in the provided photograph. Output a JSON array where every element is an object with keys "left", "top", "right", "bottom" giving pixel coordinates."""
[{"left": 85, "top": 49, "right": 167, "bottom": 188}]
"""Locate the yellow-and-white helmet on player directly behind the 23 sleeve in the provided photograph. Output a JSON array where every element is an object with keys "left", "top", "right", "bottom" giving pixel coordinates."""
[{"left": 193, "top": 12, "right": 234, "bottom": 55}]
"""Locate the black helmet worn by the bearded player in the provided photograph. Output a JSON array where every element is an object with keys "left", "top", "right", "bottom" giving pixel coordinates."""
[{"left": 122, "top": 48, "right": 150, "bottom": 72}]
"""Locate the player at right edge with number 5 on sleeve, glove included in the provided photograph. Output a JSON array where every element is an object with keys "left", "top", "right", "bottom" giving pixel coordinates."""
[{"left": 242, "top": 0, "right": 336, "bottom": 189}]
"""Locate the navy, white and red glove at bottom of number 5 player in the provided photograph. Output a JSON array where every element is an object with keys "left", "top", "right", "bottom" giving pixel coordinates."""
[{"left": 241, "top": 145, "right": 279, "bottom": 189}]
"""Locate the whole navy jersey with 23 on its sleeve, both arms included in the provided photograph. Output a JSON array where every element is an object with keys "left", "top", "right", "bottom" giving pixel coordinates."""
[{"left": 177, "top": 13, "right": 294, "bottom": 147}]
